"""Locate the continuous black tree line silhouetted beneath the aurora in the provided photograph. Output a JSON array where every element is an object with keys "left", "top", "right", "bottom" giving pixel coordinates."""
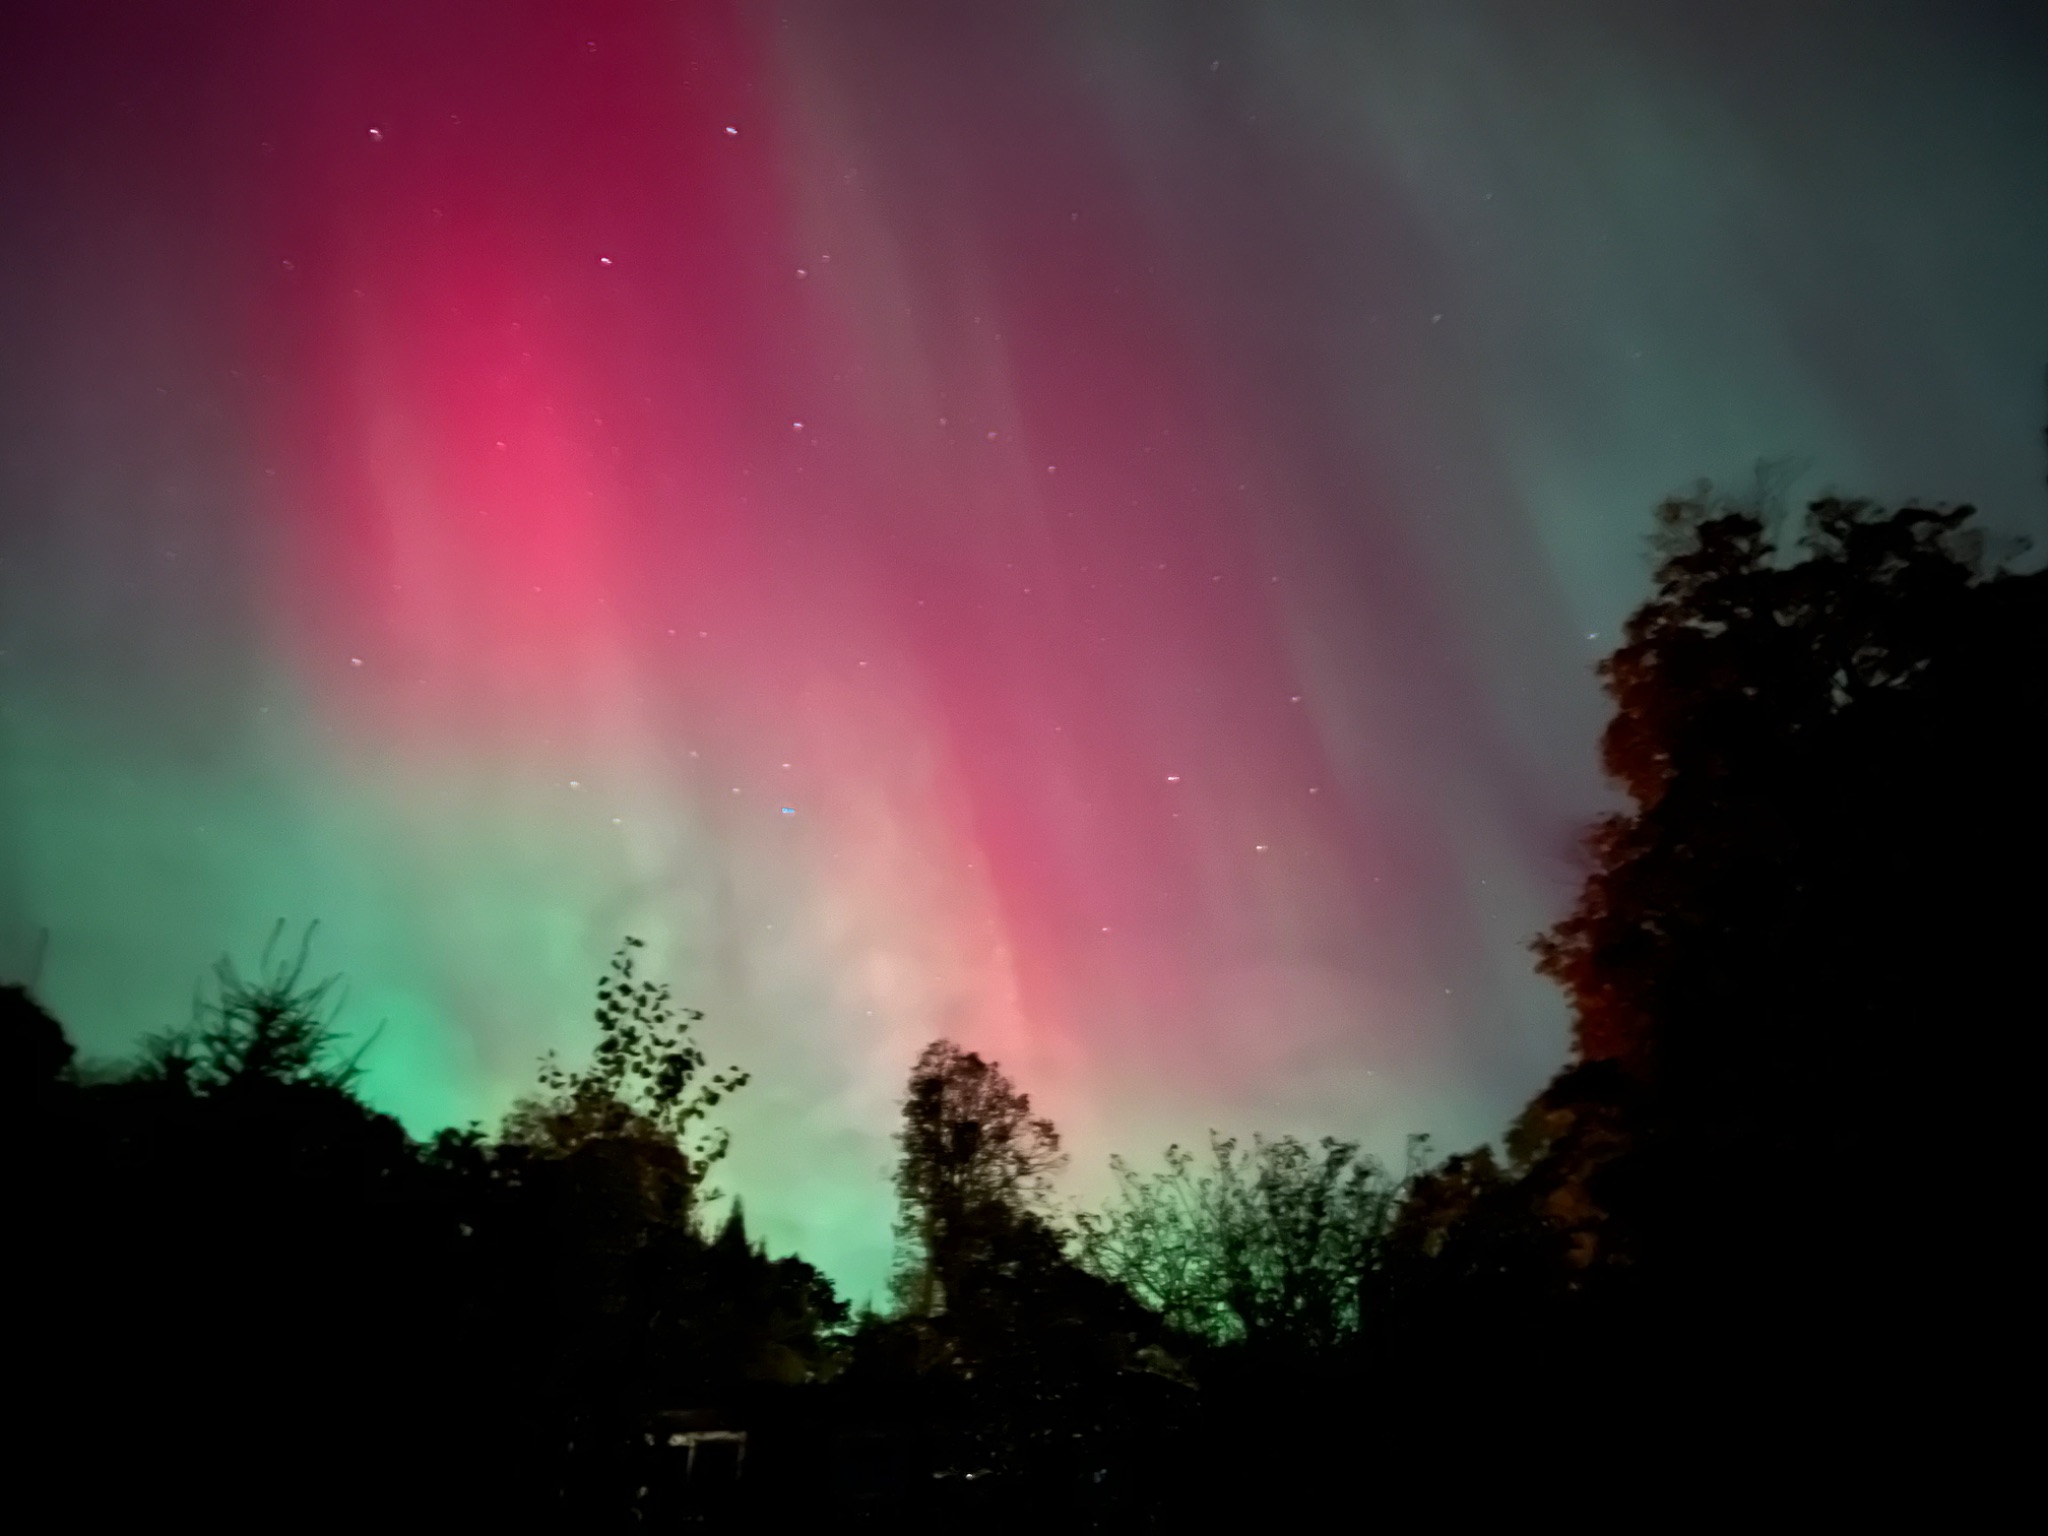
[{"left": 0, "top": 489, "right": 2048, "bottom": 1530}]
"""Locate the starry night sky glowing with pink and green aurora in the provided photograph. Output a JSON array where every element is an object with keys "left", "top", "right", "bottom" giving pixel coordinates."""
[{"left": 0, "top": 0, "right": 2048, "bottom": 1296}]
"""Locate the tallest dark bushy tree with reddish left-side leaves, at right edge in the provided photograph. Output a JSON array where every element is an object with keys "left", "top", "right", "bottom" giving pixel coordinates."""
[{"left": 1538, "top": 496, "right": 2048, "bottom": 1155}]
